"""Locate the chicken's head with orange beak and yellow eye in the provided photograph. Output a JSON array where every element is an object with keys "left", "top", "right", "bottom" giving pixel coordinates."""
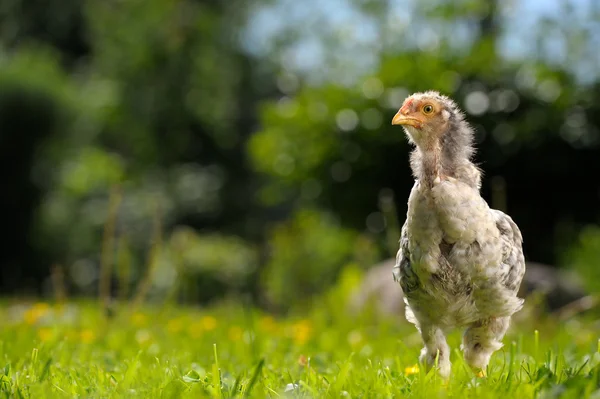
[{"left": 392, "top": 91, "right": 457, "bottom": 147}]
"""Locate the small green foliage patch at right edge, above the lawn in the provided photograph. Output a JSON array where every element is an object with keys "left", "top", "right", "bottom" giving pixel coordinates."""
[{"left": 562, "top": 225, "right": 600, "bottom": 293}]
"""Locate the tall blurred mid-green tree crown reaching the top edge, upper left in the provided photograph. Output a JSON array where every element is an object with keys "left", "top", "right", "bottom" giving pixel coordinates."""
[{"left": 87, "top": 0, "right": 245, "bottom": 167}]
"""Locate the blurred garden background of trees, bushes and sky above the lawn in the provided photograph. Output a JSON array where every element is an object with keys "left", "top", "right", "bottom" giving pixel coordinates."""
[{"left": 0, "top": 0, "right": 600, "bottom": 311}]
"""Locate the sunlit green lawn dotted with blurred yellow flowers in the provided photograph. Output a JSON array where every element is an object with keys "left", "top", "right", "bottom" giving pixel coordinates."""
[{"left": 0, "top": 295, "right": 600, "bottom": 398}]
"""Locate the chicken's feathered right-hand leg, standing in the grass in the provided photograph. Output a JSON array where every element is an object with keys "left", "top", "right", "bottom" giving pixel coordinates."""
[{"left": 462, "top": 317, "right": 510, "bottom": 373}]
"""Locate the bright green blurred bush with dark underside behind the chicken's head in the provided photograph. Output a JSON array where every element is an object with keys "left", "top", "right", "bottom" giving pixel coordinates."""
[{"left": 248, "top": 34, "right": 600, "bottom": 263}]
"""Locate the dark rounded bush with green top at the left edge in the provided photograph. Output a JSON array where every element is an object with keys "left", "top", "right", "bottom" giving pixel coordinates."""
[{"left": 0, "top": 47, "right": 83, "bottom": 292}]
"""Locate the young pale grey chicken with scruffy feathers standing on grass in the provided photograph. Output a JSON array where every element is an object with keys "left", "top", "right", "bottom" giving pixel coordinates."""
[{"left": 392, "top": 91, "right": 525, "bottom": 378}]
